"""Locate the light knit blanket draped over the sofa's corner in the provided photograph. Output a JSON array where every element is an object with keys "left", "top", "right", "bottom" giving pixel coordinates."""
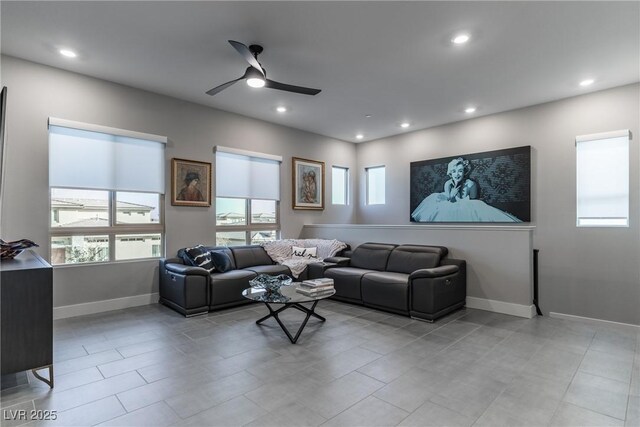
[{"left": 262, "top": 239, "right": 347, "bottom": 278}]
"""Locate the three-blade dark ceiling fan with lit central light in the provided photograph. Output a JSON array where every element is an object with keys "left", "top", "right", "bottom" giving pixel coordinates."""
[{"left": 207, "top": 40, "right": 320, "bottom": 96}]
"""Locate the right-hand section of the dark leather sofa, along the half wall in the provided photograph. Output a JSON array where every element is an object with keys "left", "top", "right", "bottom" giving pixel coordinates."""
[{"left": 323, "top": 243, "right": 467, "bottom": 321}]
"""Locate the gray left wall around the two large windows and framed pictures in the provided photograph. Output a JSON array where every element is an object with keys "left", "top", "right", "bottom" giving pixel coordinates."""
[{"left": 0, "top": 56, "right": 357, "bottom": 307}]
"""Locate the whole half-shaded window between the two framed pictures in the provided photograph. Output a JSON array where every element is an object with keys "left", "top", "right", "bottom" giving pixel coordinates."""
[{"left": 216, "top": 146, "right": 282, "bottom": 246}]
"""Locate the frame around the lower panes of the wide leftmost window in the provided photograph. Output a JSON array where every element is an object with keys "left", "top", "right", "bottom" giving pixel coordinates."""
[{"left": 47, "top": 187, "right": 166, "bottom": 267}]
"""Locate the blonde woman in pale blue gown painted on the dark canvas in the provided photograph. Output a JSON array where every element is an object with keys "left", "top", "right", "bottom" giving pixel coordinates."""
[{"left": 411, "top": 157, "right": 522, "bottom": 222}]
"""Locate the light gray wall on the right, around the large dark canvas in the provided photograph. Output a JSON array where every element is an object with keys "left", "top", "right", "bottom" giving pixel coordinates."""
[{"left": 356, "top": 84, "right": 640, "bottom": 325}]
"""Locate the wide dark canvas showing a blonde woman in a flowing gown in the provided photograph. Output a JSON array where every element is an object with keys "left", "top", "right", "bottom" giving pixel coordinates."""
[{"left": 409, "top": 146, "right": 531, "bottom": 223}]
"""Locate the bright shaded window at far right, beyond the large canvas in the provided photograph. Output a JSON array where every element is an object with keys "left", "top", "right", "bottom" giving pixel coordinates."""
[{"left": 576, "top": 130, "right": 629, "bottom": 227}]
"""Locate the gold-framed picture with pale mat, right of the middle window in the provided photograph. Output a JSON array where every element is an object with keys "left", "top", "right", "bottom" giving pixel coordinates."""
[{"left": 292, "top": 157, "right": 324, "bottom": 210}]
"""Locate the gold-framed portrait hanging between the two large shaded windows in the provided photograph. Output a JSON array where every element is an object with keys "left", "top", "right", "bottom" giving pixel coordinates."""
[{"left": 171, "top": 159, "right": 211, "bottom": 206}]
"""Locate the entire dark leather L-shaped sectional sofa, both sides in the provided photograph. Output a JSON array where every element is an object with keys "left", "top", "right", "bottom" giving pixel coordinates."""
[{"left": 160, "top": 243, "right": 467, "bottom": 321}]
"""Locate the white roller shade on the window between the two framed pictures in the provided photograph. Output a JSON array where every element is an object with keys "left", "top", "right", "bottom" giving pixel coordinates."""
[{"left": 216, "top": 147, "right": 282, "bottom": 200}]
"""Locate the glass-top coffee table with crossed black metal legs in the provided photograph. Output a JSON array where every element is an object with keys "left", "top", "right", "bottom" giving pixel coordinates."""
[{"left": 242, "top": 283, "right": 336, "bottom": 344}]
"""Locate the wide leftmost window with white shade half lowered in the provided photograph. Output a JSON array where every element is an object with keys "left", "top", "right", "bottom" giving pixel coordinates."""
[{"left": 49, "top": 119, "right": 165, "bottom": 265}]
